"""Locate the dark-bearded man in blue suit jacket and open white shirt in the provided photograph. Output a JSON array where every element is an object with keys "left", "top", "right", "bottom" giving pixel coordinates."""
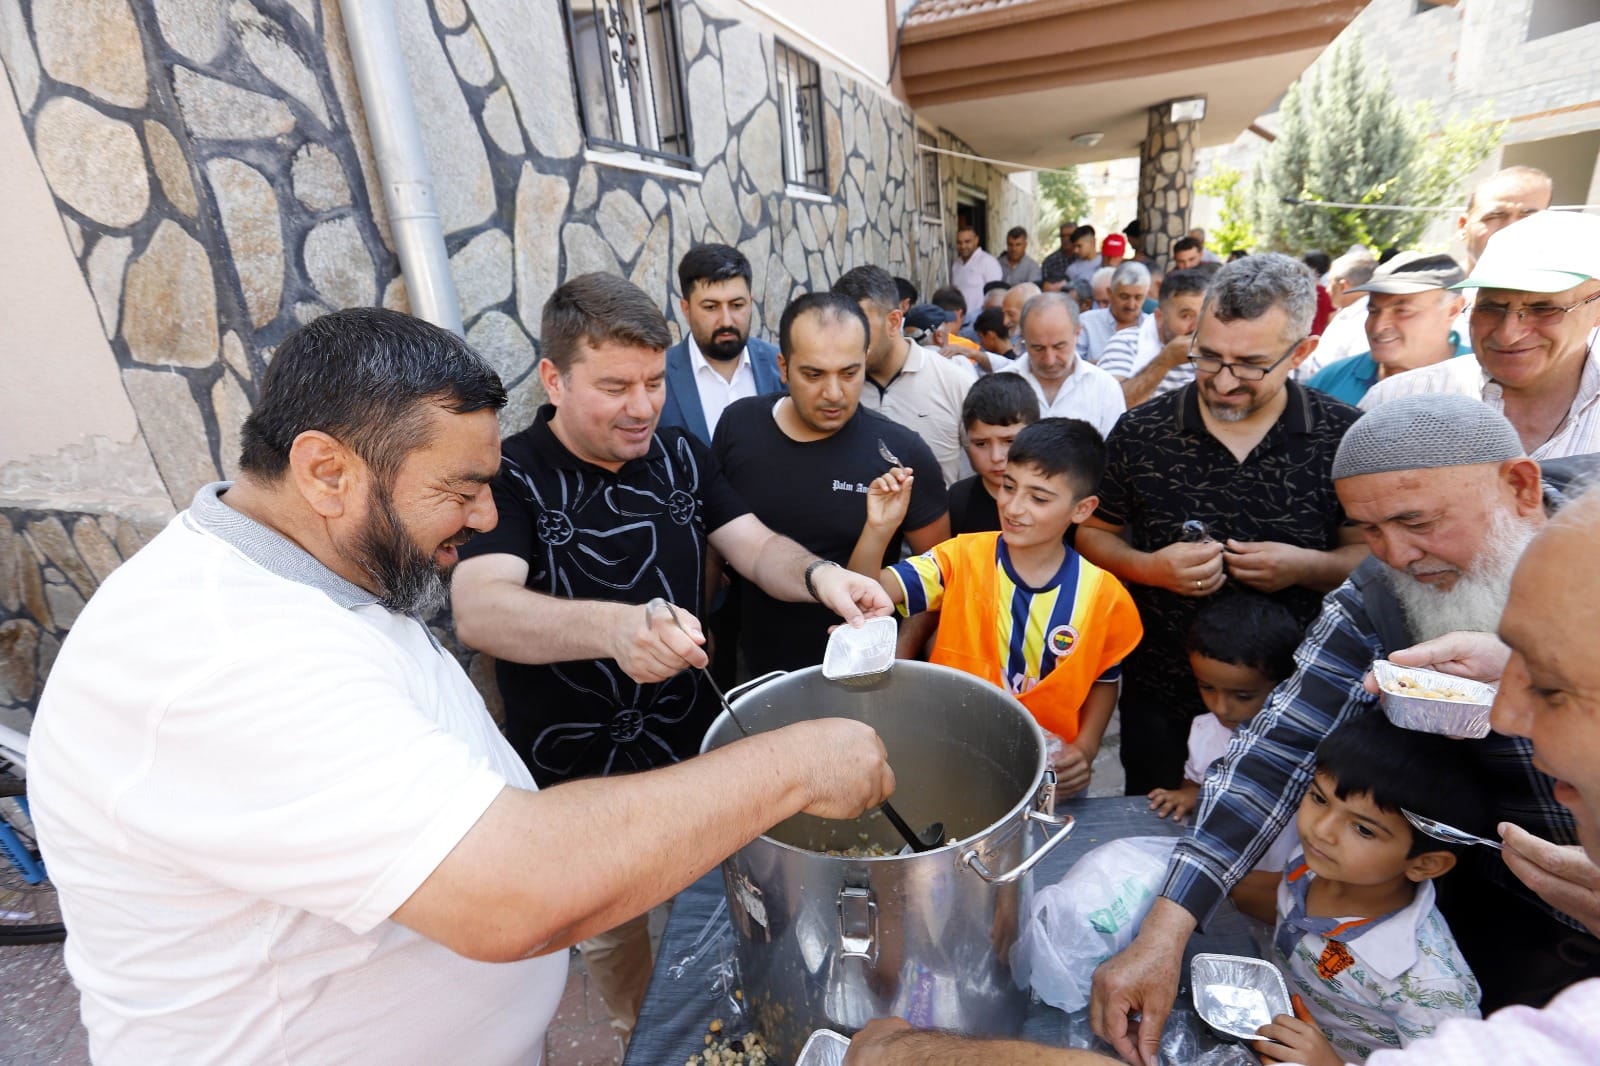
[{"left": 661, "top": 245, "right": 784, "bottom": 445}]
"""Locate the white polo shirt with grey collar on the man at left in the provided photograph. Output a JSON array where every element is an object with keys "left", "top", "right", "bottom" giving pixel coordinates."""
[{"left": 29, "top": 485, "right": 566, "bottom": 1066}]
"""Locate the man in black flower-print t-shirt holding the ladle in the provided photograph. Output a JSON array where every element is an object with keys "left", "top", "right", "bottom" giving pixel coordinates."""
[{"left": 457, "top": 274, "right": 891, "bottom": 1039}]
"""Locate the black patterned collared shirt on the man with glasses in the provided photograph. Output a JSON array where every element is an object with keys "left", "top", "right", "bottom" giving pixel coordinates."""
[{"left": 1094, "top": 381, "right": 1360, "bottom": 715}]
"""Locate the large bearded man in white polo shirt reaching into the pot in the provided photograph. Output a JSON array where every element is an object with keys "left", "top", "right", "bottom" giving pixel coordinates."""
[{"left": 29, "top": 307, "right": 893, "bottom": 1066}]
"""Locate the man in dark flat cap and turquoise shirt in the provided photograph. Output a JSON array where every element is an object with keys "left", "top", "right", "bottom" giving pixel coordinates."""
[{"left": 1306, "top": 251, "right": 1472, "bottom": 403}]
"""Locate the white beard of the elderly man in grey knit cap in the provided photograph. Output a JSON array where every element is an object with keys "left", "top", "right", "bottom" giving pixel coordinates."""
[{"left": 1384, "top": 511, "right": 1538, "bottom": 642}]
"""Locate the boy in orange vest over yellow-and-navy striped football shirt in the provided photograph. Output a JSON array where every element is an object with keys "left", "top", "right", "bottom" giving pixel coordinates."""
[{"left": 850, "top": 418, "right": 1144, "bottom": 795}]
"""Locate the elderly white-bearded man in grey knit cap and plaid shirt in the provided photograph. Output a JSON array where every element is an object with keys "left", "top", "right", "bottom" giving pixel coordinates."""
[{"left": 1091, "top": 395, "right": 1600, "bottom": 1061}]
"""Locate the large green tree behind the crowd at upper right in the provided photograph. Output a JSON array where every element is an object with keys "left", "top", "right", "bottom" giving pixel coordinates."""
[{"left": 1245, "top": 38, "right": 1504, "bottom": 254}]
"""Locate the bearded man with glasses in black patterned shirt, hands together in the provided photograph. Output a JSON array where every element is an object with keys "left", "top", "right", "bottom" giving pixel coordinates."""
[{"left": 1077, "top": 254, "right": 1366, "bottom": 795}]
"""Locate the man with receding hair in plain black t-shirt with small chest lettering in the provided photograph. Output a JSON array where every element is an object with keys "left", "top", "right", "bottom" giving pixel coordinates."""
[{"left": 712, "top": 293, "right": 950, "bottom": 674}]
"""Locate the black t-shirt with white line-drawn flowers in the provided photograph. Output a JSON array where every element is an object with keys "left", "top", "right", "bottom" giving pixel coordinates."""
[{"left": 461, "top": 405, "right": 749, "bottom": 786}]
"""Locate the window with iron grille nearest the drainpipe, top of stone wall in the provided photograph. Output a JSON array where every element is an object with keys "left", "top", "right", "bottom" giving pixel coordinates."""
[{"left": 562, "top": 0, "right": 691, "bottom": 166}]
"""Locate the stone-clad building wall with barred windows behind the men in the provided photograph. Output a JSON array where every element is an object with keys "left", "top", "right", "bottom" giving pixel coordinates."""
[{"left": 0, "top": 0, "right": 1034, "bottom": 730}]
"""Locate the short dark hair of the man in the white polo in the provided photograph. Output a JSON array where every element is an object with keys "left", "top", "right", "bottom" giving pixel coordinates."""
[{"left": 238, "top": 307, "right": 506, "bottom": 485}]
